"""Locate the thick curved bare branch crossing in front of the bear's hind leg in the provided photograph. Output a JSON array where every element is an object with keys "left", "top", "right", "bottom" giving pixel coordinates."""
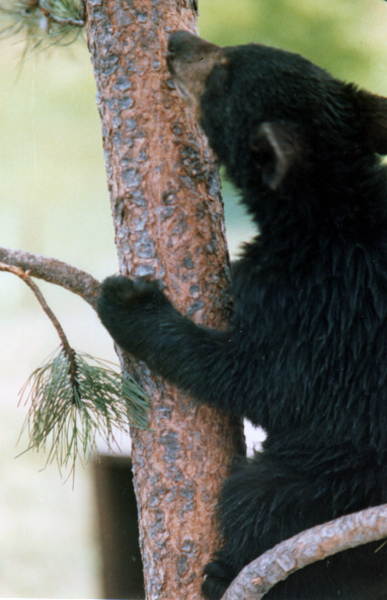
[{"left": 222, "top": 504, "right": 387, "bottom": 600}]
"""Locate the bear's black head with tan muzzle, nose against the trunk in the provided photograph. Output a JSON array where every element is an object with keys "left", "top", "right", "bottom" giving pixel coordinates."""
[{"left": 167, "top": 31, "right": 387, "bottom": 205}]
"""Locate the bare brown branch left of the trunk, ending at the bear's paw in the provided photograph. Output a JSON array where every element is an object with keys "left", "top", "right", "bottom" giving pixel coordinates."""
[{"left": 0, "top": 248, "right": 101, "bottom": 310}]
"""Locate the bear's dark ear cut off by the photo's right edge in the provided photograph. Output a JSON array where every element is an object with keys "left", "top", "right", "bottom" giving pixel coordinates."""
[{"left": 357, "top": 90, "right": 387, "bottom": 154}]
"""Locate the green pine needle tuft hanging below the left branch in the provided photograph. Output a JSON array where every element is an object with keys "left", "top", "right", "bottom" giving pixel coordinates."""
[{"left": 20, "top": 347, "right": 150, "bottom": 472}]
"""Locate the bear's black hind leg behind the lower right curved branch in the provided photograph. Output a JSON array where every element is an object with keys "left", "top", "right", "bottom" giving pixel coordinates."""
[{"left": 202, "top": 451, "right": 387, "bottom": 600}]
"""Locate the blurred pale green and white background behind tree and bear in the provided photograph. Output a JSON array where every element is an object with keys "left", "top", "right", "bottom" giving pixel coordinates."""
[{"left": 0, "top": 0, "right": 387, "bottom": 598}]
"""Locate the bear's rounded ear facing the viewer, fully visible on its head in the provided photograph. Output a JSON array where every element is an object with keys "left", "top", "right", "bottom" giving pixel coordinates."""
[{"left": 250, "top": 121, "right": 301, "bottom": 191}]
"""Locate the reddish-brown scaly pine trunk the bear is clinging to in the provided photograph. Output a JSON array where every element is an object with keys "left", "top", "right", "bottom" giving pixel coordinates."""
[{"left": 87, "top": 0, "right": 246, "bottom": 600}]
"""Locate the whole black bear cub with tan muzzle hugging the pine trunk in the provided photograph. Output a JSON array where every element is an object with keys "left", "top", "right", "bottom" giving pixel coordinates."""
[{"left": 98, "top": 31, "right": 387, "bottom": 600}]
